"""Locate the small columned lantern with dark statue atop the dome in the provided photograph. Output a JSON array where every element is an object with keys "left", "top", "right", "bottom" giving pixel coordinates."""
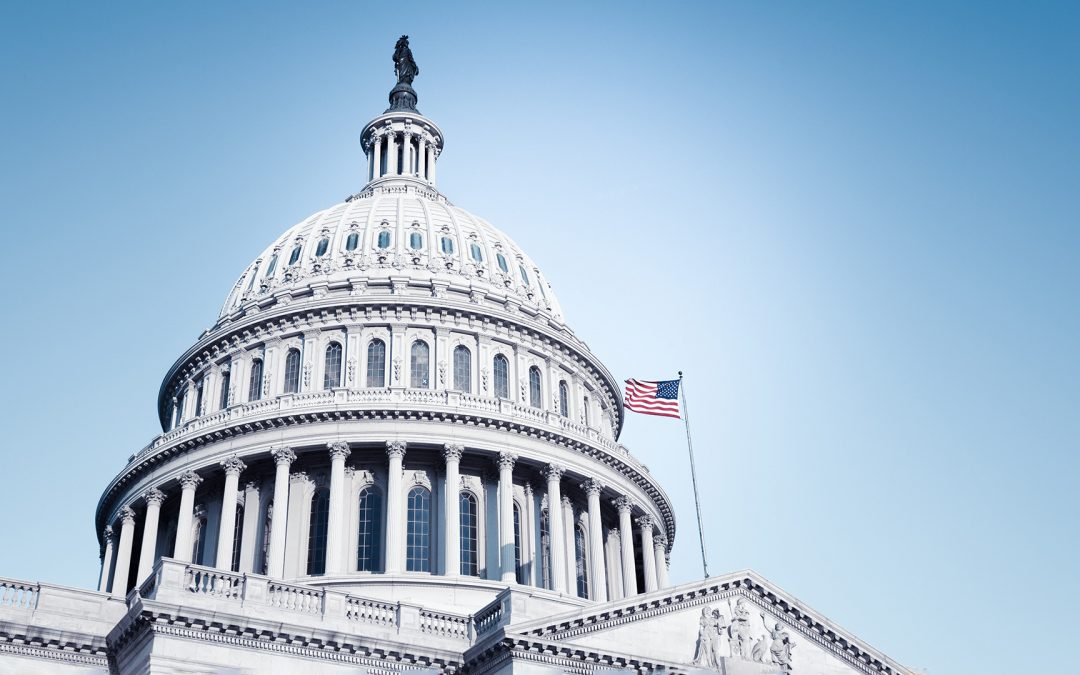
[{"left": 361, "top": 36, "right": 443, "bottom": 186}]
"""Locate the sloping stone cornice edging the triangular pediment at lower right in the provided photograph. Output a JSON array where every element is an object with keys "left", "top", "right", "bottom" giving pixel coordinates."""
[{"left": 508, "top": 570, "right": 915, "bottom": 675}]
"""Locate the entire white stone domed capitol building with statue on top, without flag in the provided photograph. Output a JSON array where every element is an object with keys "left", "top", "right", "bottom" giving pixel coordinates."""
[{"left": 0, "top": 43, "right": 909, "bottom": 675}]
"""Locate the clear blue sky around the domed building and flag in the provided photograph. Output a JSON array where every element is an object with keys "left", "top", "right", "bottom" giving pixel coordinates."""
[{"left": 0, "top": 2, "right": 1080, "bottom": 675}]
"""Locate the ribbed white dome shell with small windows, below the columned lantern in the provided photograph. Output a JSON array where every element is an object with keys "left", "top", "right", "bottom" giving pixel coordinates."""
[{"left": 218, "top": 177, "right": 563, "bottom": 324}]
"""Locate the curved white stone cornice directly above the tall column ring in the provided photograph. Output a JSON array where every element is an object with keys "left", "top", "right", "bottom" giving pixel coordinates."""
[{"left": 96, "top": 406, "right": 675, "bottom": 550}]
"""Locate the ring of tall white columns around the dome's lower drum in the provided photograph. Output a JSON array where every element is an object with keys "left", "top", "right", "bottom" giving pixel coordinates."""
[{"left": 99, "top": 441, "right": 669, "bottom": 602}]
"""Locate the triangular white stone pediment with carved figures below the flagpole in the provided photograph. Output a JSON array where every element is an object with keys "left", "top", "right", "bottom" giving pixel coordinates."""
[{"left": 505, "top": 572, "right": 912, "bottom": 675}]
